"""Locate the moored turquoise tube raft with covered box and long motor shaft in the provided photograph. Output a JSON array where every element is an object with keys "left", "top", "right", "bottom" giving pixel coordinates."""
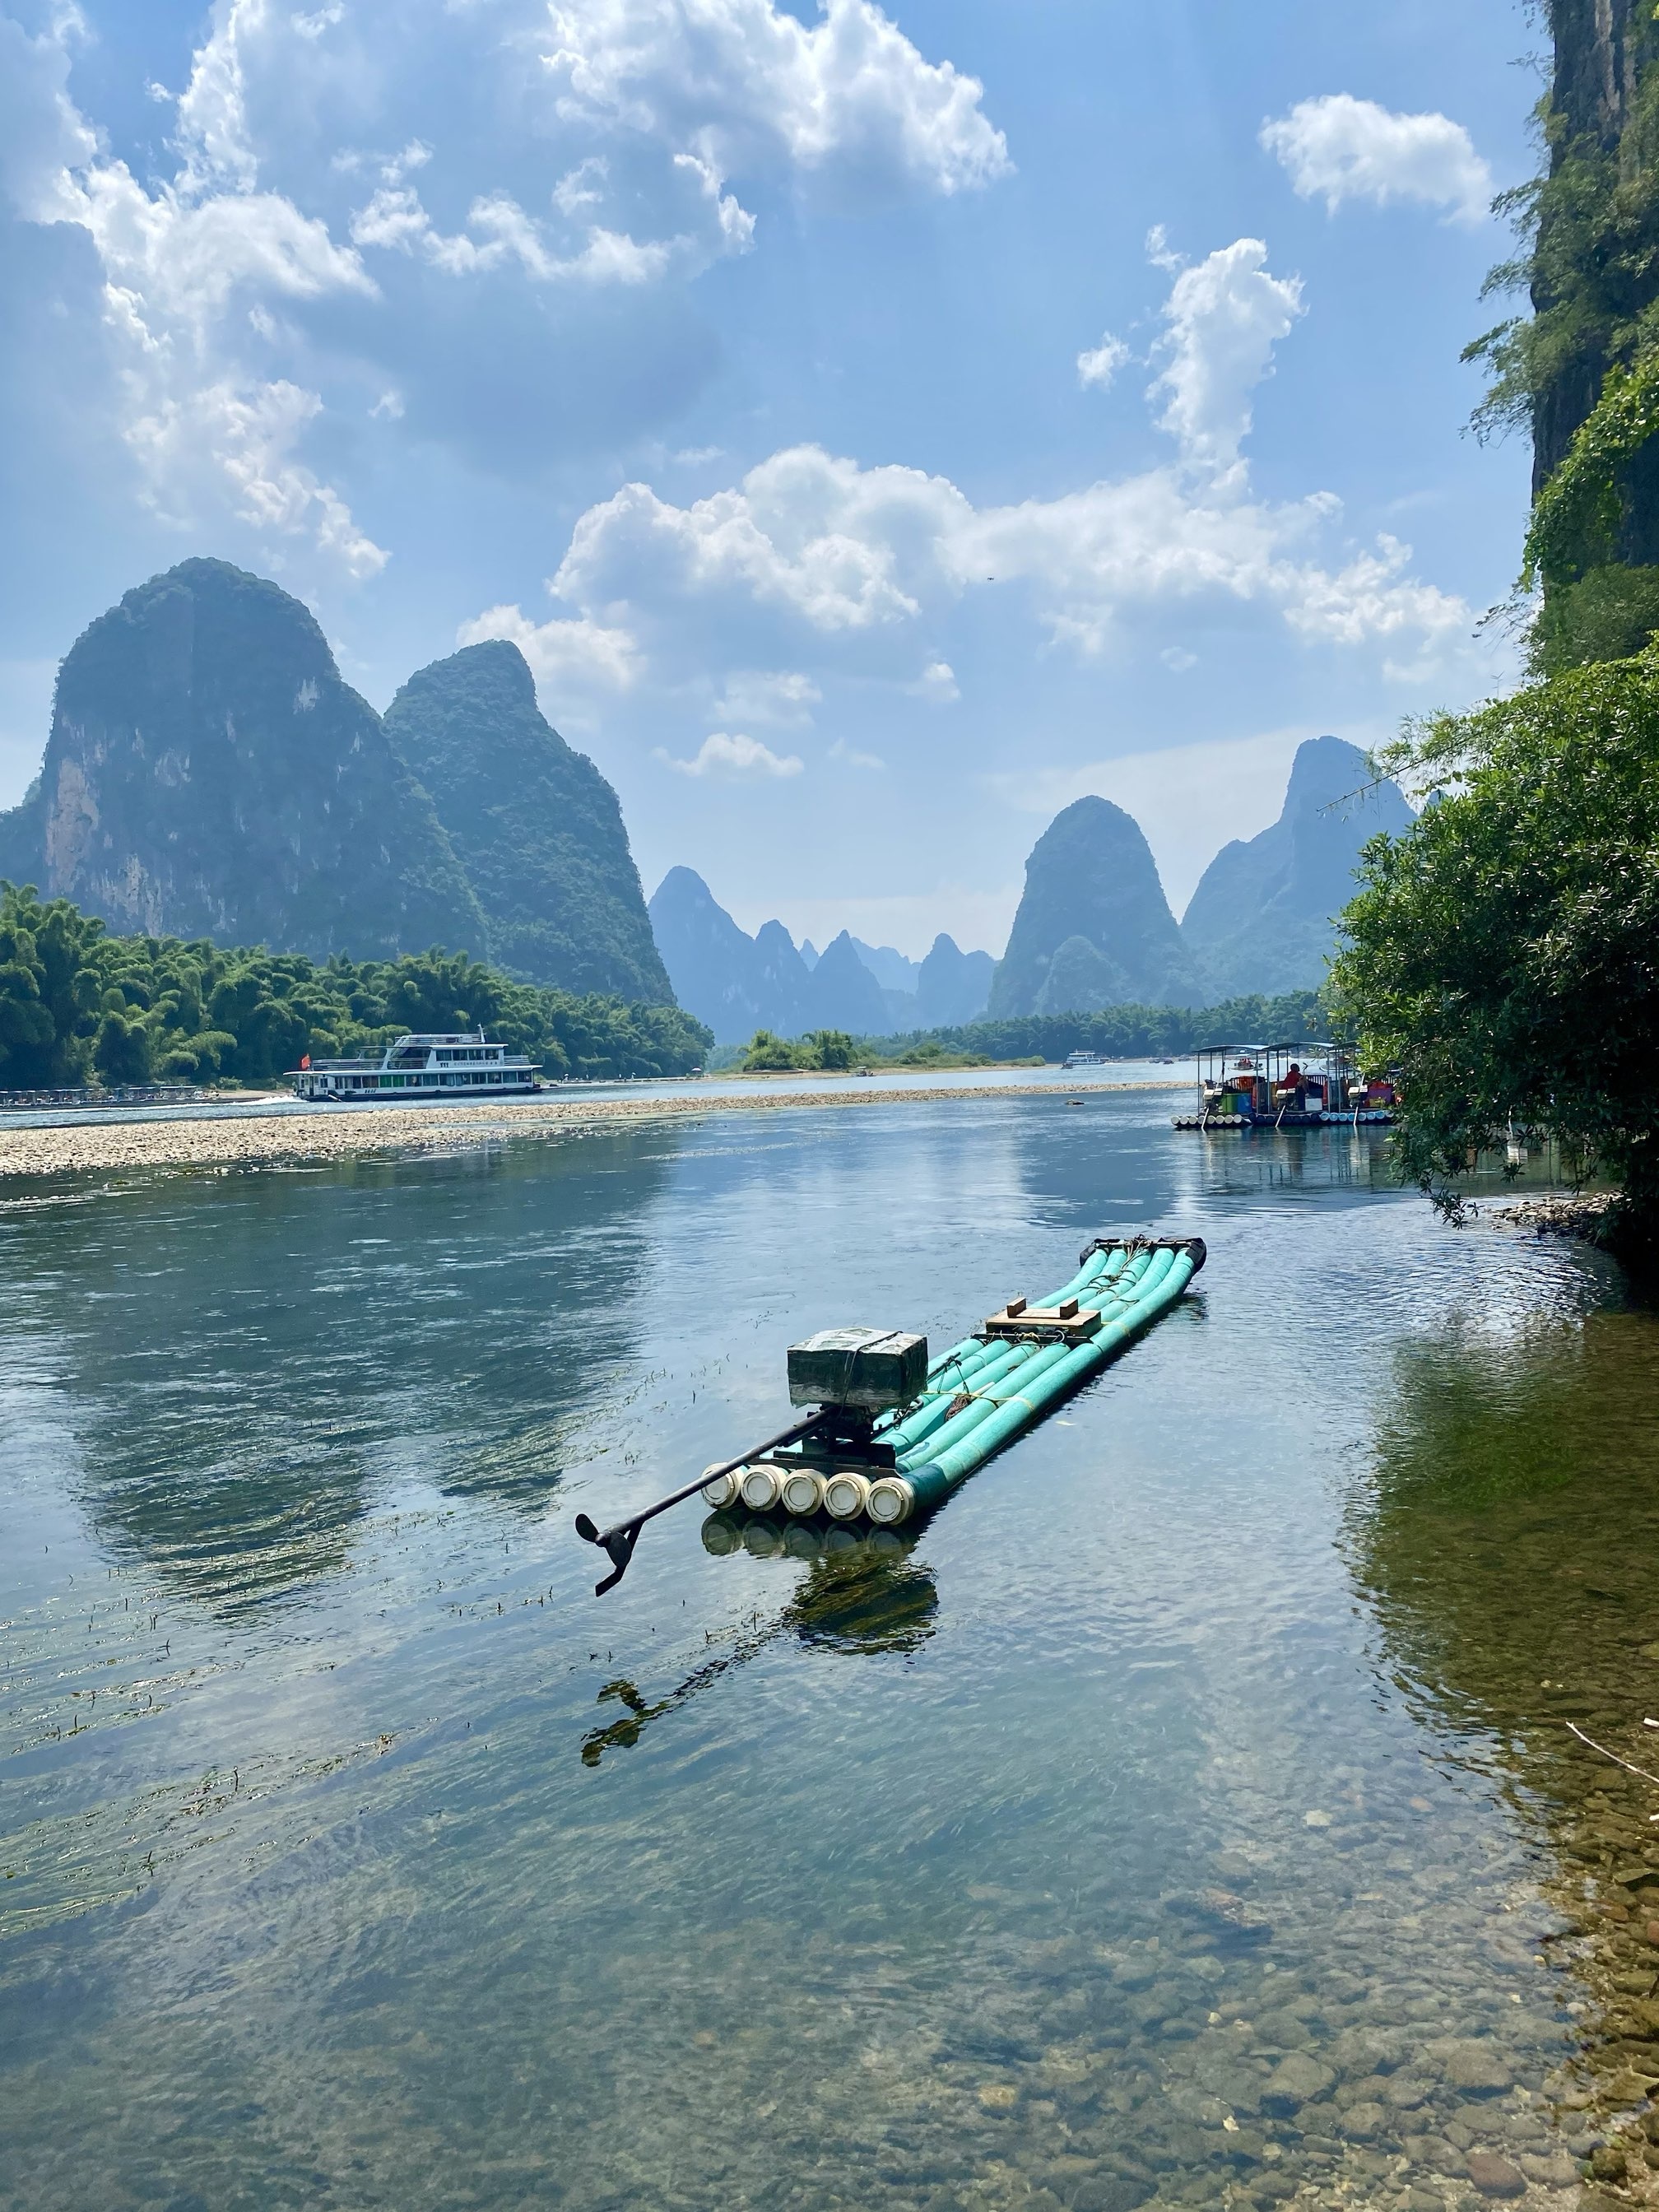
[{"left": 575, "top": 1237, "right": 1206, "bottom": 1595}]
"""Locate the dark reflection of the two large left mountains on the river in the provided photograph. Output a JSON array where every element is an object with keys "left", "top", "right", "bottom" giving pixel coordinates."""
[{"left": 9, "top": 1139, "right": 662, "bottom": 1608}]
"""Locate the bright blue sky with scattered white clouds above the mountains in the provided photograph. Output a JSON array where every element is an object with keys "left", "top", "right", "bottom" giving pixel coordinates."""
[{"left": 0, "top": 0, "right": 1540, "bottom": 954}]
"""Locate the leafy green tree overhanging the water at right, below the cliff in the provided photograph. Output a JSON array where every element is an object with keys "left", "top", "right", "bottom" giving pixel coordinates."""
[{"left": 1331, "top": 653, "right": 1659, "bottom": 1257}]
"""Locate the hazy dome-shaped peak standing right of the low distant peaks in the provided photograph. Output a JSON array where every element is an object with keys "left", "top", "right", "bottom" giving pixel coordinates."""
[{"left": 989, "top": 798, "right": 1203, "bottom": 1017}]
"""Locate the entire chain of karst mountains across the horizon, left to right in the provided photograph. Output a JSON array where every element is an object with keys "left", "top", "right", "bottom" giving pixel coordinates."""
[{"left": 0, "top": 560, "right": 1414, "bottom": 1044}]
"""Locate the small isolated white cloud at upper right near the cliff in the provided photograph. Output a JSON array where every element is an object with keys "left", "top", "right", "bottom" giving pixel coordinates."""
[{"left": 1261, "top": 93, "right": 1491, "bottom": 223}]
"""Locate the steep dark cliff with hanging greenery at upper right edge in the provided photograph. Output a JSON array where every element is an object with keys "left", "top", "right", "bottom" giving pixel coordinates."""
[{"left": 1466, "top": 0, "right": 1659, "bottom": 675}]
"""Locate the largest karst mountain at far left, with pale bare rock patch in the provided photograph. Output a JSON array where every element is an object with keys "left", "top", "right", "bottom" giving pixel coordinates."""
[{"left": 0, "top": 560, "right": 486, "bottom": 958}]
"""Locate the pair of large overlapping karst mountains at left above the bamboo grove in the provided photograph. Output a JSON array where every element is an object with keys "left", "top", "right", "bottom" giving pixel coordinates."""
[{"left": 0, "top": 560, "right": 672, "bottom": 1004}]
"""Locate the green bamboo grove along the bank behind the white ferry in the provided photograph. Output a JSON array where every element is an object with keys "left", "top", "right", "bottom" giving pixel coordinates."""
[{"left": 0, "top": 883, "right": 714, "bottom": 1090}]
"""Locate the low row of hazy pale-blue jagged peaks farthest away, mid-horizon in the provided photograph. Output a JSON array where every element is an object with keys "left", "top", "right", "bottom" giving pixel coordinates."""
[{"left": 650, "top": 867, "right": 996, "bottom": 1044}]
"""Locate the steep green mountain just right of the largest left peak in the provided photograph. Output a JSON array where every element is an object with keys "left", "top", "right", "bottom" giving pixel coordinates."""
[{"left": 385, "top": 639, "right": 672, "bottom": 1004}]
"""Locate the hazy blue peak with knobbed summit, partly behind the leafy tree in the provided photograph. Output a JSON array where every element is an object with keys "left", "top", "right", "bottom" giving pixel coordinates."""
[{"left": 1181, "top": 737, "right": 1414, "bottom": 1000}]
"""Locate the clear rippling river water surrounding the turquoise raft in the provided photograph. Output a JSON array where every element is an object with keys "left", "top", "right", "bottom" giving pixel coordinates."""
[{"left": 0, "top": 1093, "right": 1659, "bottom": 2212}]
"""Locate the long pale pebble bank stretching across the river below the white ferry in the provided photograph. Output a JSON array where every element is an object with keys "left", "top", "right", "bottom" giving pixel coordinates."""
[{"left": 0, "top": 1081, "right": 1181, "bottom": 1179}]
